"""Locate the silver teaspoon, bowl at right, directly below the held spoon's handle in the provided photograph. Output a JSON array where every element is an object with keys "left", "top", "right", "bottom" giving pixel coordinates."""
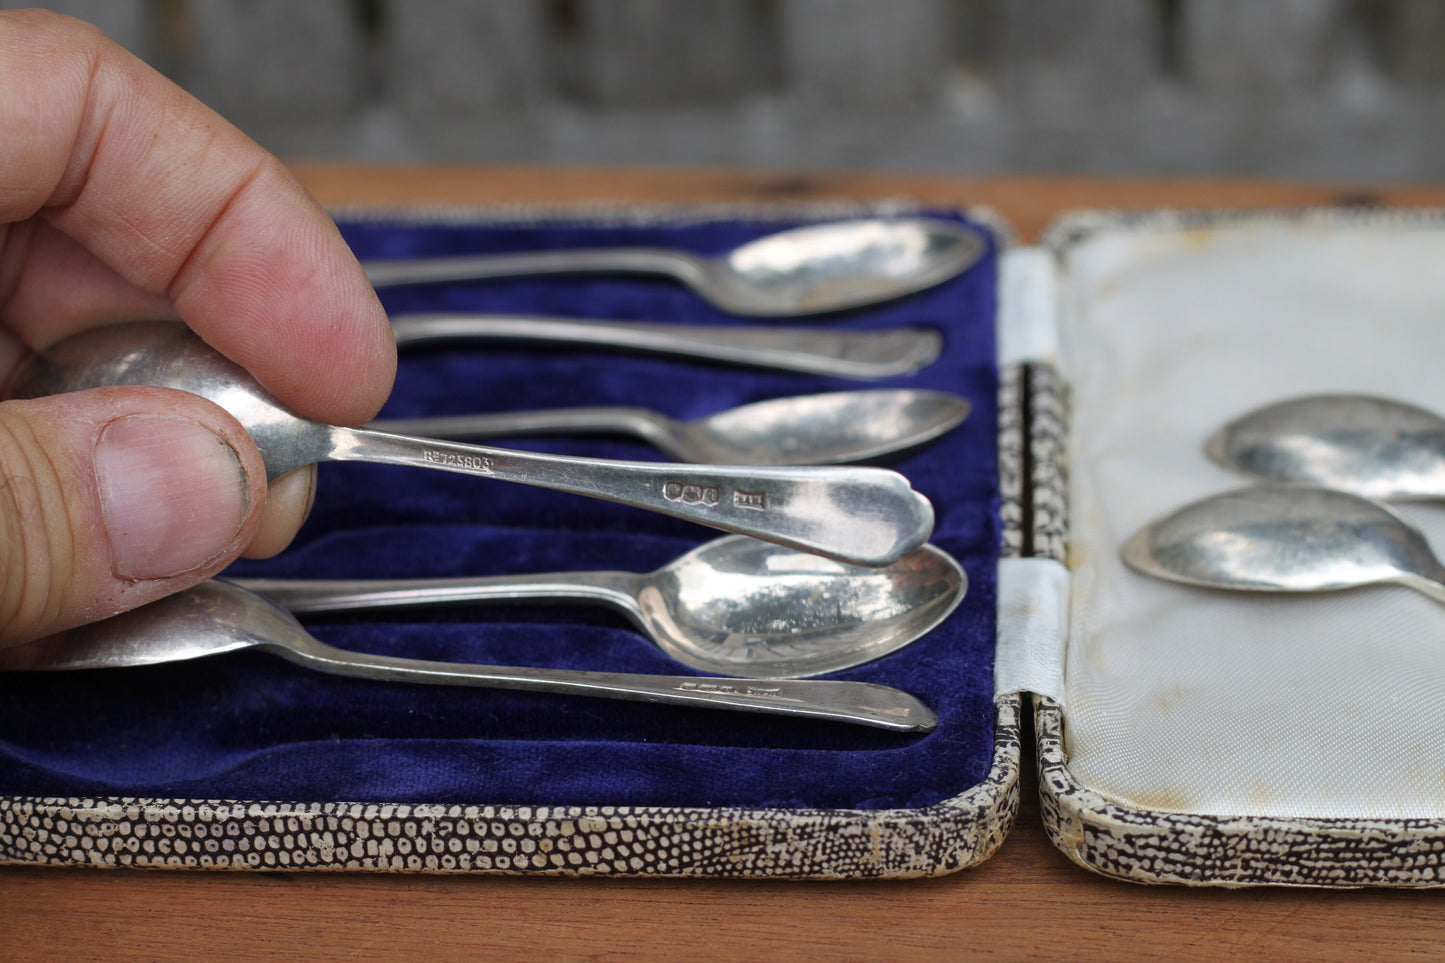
[{"left": 231, "top": 535, "right": 968, "bottom": 678}]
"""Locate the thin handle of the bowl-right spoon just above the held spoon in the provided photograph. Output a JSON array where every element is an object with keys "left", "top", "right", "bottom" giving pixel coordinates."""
[{"left": 367, "top": 406, "right": 678, "bottom": 457}]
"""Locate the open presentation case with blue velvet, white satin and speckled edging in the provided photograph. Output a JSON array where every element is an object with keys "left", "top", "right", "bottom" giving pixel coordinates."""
[{"left": 0, "top": 204, "right": 1445, "bottom": 886}]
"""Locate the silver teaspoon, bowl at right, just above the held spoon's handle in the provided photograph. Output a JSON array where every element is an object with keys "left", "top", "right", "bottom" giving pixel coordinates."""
[{"left": 368, "top": 389, "right": 970, "bottom": 464}]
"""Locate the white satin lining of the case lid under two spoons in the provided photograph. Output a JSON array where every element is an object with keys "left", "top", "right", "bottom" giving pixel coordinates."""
[{"left": 1061, "top": 218, "right": 1445, "bottom": 818}]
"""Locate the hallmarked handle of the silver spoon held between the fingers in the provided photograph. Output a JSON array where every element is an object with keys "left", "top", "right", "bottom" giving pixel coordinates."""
[{"left": 324, "top": 428, "right": 933, "bottom": 565}]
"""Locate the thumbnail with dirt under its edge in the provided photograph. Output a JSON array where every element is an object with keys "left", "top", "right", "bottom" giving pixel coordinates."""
[{"left": 95, "top": 415, "right": 247, "bottom": 578}]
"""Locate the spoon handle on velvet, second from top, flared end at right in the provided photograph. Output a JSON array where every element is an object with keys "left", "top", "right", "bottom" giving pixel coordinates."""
[{"left": 392, "top": 314, "right": 942, "bottom": 380}]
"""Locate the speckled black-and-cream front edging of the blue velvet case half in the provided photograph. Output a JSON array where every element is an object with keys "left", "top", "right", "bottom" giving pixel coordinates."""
[{"left": 0, "top": 685, "right": 1020, "bottom": 879}]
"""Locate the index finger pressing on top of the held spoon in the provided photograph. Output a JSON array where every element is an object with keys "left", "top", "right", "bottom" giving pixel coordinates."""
[{"left": 0, "top": 10, "right": 396, "bottom": 424}]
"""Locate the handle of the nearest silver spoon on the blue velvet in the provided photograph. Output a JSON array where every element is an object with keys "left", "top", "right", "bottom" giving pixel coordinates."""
[{"left": 264, "top": 638, "right": 938, "bottom": 732}]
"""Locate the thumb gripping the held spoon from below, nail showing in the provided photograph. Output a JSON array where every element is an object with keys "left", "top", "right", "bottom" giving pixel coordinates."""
[{"left": 0, "top": 388, "right": 266, "bottom": 646}]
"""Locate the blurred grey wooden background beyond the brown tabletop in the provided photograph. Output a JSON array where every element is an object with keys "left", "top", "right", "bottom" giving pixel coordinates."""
[{"left": 11, "top": 0, "right": 1445, "bottom": 181}]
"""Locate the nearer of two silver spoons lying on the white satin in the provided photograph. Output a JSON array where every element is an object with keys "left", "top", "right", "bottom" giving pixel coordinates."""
[{"left": 1123, "top": 486, "right": 1445, "bottom": 602}]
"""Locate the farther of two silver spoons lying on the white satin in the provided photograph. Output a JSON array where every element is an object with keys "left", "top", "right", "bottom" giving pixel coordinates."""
[{"left": 1205, "top": 395, "right": 1445, "bottom": 499}]
